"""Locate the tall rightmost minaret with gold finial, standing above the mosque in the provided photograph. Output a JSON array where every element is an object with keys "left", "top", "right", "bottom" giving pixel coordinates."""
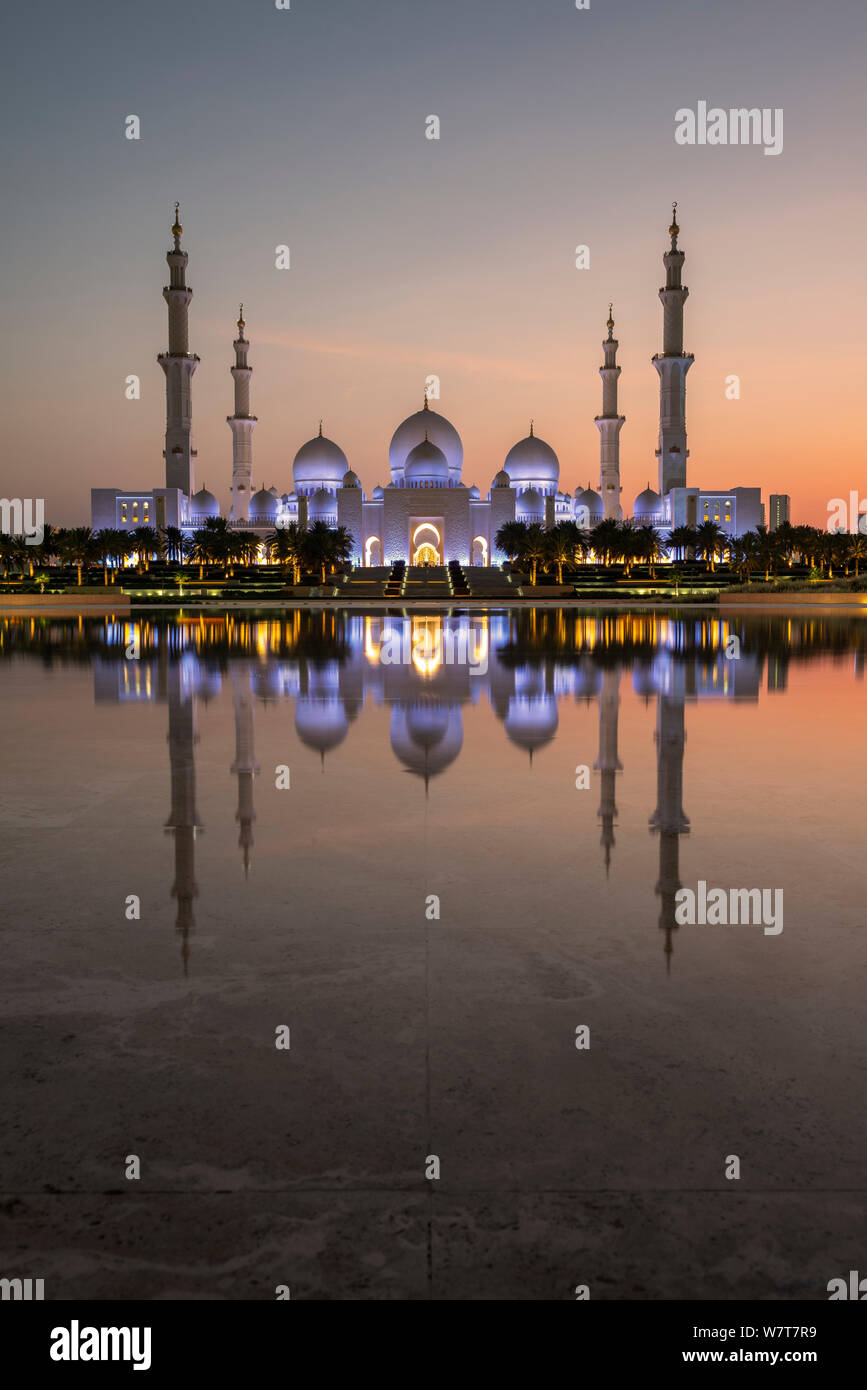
[{"left": 653, "top": 203, "right": 693, "bottom": 498}]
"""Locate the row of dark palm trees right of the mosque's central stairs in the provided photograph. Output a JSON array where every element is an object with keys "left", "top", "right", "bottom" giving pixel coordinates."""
[{"left": 496, "top": 520, "right": 867, "bottom": 584}]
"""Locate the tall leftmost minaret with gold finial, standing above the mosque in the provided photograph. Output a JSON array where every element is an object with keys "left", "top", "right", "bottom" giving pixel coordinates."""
[{"left": 157, "top": 203, "right": 199, "bottom": 498}]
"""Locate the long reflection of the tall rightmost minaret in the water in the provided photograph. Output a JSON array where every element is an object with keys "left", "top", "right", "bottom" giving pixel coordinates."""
[{"left": 650, "top": 695, "right": 689, "bottom": 967}]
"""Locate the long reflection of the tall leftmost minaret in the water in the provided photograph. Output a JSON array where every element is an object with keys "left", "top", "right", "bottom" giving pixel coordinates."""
[{"left": 165, "top": 662, "right": 201, "bottom": 974}]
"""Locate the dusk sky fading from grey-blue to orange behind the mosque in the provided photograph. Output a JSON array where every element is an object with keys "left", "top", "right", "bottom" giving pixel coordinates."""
[{"left": 0, "top": 0, "right": 867, "bottom": 525}]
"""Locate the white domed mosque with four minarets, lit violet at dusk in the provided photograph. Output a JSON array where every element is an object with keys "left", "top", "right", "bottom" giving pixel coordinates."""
[{"left": 92, "top": 203, "right": 764, "bottom": 566}]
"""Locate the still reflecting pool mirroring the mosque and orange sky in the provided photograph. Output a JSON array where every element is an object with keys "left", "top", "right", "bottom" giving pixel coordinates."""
[{"left": 0, "top": 609, "right": 867, "bottom": 1300}]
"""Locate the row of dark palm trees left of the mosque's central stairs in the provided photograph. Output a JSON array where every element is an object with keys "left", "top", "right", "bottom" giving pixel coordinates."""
[{"left": 0, "top": 517, "right": 353, "bottom": 585}]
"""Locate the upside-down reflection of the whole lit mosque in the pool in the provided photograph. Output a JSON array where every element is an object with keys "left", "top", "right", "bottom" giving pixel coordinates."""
[{"left": 94, "top": 614, "right": 772, "bottom": 970}]
